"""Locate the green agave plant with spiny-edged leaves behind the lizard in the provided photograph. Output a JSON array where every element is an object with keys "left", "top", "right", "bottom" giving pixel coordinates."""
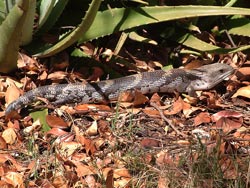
[{"left": 0, "top": 0, "right": 250, "bottom": 73}]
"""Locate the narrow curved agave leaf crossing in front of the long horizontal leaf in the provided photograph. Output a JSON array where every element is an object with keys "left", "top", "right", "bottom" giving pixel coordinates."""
[{"left": 34, "top": 0, "right": 101, "bottom": 57}]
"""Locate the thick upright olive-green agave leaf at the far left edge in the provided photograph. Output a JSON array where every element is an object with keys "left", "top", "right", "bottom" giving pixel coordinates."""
[{"left": 0, "top": 0, "right": 29, "bottom": 73}]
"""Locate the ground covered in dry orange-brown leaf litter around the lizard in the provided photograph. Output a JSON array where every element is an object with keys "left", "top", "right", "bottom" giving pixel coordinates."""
[{"left": 0, "top": 41, "right": 250, "bottom": 188}]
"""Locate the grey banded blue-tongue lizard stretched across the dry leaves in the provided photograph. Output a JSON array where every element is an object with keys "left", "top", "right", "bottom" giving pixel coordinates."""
[{"left": 5, "top": 63, "right": 234, "bottom": 115}]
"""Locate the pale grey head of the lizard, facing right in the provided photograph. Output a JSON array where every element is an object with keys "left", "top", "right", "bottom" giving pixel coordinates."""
[{"left": 187, "top": 63, "right": 234, "bottom": 92}]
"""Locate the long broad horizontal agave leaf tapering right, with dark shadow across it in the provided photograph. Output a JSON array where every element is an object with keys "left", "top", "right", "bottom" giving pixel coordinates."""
[{"left": 79, "top": 6, "right": 250, "bottom": 43}]
